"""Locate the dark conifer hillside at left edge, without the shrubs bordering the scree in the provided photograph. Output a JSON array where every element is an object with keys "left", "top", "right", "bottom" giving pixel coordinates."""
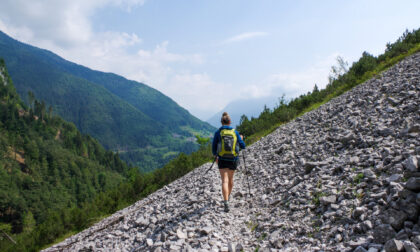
[{"left": 0, "top": 60, "right": 128, "bottom": 246}]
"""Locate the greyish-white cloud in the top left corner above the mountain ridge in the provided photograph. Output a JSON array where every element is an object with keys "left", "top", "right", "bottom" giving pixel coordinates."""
[{"left": 0, "top": 0, "right": 145, "bottom": 48}]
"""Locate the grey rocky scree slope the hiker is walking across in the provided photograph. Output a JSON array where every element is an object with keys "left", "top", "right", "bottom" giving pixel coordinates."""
[{"left": 45, "top": 54, "right": 420, "bottom": 252}]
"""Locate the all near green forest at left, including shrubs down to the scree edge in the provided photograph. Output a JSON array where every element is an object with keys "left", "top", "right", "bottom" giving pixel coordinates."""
[{"left": 0, "top": 60, "right": 215, "bottom": 252}]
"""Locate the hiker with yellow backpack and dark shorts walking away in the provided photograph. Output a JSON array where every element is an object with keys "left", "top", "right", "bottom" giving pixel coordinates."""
[{"left": 212, "top": 112, "right": 245, "bottom": 212}]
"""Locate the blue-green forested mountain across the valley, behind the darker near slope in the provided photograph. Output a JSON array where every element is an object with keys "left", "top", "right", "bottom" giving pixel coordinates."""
[{"left": 0, "top": 32, "right": 214, "bottom": 171}]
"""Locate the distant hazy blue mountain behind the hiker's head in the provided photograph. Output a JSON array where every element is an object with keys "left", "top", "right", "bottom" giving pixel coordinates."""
[{"left": 206, "top": 96, "right": 279, "bottom": 128}]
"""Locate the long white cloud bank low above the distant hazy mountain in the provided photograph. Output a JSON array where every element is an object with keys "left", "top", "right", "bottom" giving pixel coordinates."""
[{"left": 166, "top": 53, "right": 338, "bottom": 119}]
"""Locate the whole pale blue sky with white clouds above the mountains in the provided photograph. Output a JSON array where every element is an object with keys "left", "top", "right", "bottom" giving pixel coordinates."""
[{"left": 0, "top": 0, "right": 420, "bottom": 120}]
